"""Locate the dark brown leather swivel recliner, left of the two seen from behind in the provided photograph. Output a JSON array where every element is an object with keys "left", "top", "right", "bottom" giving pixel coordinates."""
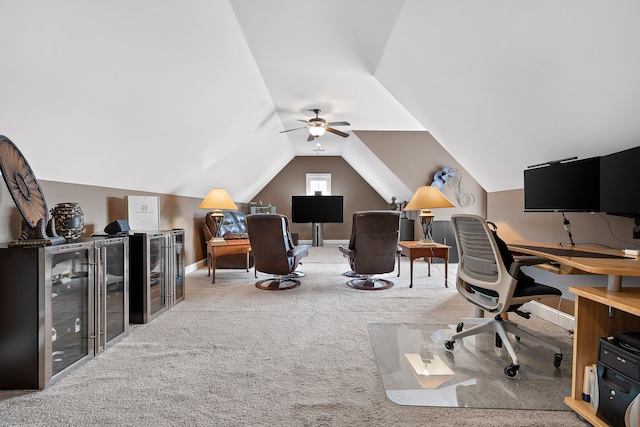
[{"left": 247, "top": 213, "right": 309, "bottom": 291}]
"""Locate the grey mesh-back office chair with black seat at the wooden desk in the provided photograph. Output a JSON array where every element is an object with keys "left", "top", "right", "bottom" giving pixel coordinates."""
[{"left": 445, "top": 214, "right": 562, "bottom": 378}]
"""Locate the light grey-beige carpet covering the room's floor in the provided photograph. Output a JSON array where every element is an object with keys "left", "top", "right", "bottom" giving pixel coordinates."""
[{"left": 0, "top": 246, "right": 584, "bottom": 426}]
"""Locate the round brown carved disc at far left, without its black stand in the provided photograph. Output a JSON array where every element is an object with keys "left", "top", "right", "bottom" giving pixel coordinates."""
[{"left": 0, "top": 135, "right": 47, "bottom": 228}]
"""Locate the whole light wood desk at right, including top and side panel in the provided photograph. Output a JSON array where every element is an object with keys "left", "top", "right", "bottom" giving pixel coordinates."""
[{"left": 508, "top": 242, "right": 640, "bottom": 426}]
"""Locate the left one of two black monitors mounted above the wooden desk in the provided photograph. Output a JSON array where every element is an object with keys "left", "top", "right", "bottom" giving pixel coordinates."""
[{"left": 524, "top": 157, "right": 600, "bottom": 212}]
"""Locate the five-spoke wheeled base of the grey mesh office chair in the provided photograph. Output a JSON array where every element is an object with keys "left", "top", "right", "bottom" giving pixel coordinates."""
[{"left": 449, "top": 316, "right": 562, "bottom": 368}]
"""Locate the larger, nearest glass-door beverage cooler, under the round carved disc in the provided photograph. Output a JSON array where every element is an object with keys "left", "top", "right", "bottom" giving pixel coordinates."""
[{"left": 0, "top": 238, "right": 129, "bottom": 389}]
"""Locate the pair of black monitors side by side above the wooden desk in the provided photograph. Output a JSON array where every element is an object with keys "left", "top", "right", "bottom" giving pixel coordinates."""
[{"left": 524, "top": 147, "right": 640, "bottom": 239}]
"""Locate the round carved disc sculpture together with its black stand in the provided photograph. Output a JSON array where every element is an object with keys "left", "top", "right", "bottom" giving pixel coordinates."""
[{"left": 0, "top": 135, "right": 65, "bottom": 246}]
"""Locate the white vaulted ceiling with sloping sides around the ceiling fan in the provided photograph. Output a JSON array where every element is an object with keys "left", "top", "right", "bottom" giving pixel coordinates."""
[{"left": 0, "top": 0, "right": 640, "bottom": 201}]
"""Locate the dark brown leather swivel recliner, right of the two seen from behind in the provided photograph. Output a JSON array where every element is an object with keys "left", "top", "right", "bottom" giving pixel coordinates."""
[{"left": 339, "top": 210, "right": 400, "bottom": 291}]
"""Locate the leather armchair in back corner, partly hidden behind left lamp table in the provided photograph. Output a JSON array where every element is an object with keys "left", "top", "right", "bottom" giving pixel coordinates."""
[{"left": 202, "top": 211, "right": 254, "bottom": 269}]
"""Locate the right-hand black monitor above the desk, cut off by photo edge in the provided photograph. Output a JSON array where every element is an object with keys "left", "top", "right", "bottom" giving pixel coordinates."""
[{"left": 600, "top": 147, "right": 640, "bottom": 218}]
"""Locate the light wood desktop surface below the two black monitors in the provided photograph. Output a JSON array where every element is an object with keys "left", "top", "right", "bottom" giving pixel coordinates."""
[{"left": 508, "top": 241, "right": 640, "bottom": 276}]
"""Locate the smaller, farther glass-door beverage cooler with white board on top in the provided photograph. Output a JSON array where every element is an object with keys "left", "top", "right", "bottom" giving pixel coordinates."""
[{"left": 129, "top": 229, "right": 185, "bottom": 323}]
